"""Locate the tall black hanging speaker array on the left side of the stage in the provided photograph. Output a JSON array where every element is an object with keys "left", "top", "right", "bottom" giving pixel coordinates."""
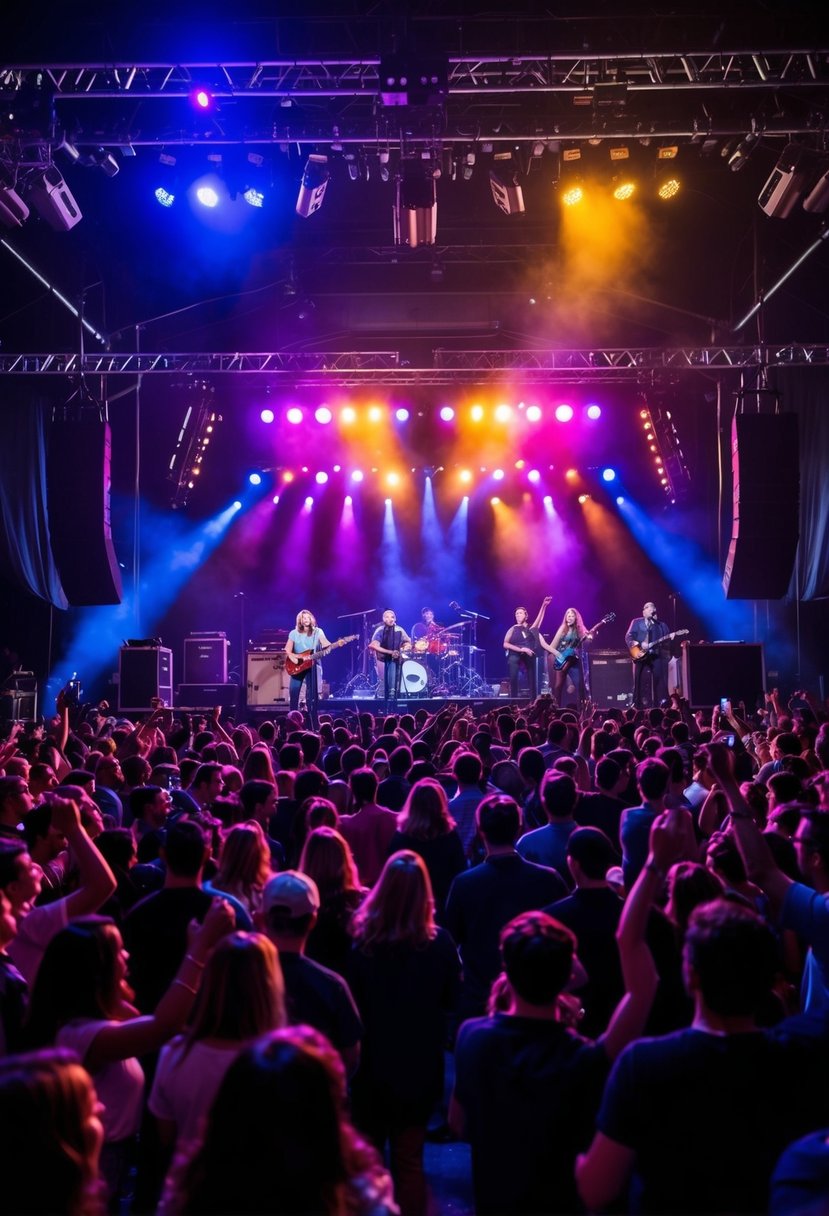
[{"left": 46, "top": 416, "right": 122, "bottom": 608}]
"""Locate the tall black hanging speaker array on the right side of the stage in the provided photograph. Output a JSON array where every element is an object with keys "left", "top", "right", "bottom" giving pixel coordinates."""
[{"left": 722, "top": 413, "right": 800, "bottom": 599}]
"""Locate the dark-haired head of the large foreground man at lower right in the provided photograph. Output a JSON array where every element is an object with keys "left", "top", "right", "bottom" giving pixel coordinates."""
[{"left": 684, "top": 900, "right": 780, "bottom": 1017}]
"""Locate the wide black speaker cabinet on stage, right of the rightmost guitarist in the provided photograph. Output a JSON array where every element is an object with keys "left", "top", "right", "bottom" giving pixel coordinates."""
[{"left": 682, "top": 642, "right": 766, "bottom": 713}]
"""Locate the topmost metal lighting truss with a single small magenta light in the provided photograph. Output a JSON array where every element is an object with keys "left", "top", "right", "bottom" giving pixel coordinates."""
[{"left": 0, "top": 46, "right": 829, "bottom": 148}]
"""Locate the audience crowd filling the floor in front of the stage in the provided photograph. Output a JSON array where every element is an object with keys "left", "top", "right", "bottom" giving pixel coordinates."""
[{"left": 0, "top": 689, "right": 829, "bottom": 1216}]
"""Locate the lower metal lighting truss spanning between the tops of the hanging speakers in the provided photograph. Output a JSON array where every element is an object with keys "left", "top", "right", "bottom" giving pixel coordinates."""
[{"left": 0, "top": 343, "right": 829, "bottom": 388}]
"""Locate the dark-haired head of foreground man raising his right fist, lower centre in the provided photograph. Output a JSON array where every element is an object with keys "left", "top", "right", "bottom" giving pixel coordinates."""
[{"left": 501, "top": 912, "right": 576, "bottom": 1006}]
